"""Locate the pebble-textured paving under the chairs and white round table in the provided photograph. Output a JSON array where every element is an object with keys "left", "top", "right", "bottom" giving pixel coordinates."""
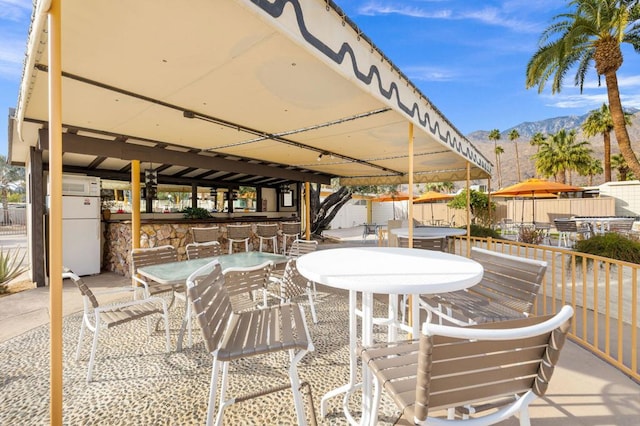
[{"left": 0, "top": 287, "right": 408, "bottom": 426}]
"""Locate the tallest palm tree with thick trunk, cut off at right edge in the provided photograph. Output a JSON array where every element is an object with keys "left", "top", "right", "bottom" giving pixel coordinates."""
[{"left": 526, "top": 0, "right": 640, "bottom": 176}]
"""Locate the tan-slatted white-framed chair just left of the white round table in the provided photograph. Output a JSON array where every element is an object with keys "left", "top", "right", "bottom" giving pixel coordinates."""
[{"left": 187, "top": 260, "right": 315, "bottom": 426}]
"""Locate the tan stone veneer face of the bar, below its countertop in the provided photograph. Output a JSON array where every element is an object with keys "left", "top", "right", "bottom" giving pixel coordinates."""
[{"left": 102, "top": 221, "right": 282, "bottom": 277}]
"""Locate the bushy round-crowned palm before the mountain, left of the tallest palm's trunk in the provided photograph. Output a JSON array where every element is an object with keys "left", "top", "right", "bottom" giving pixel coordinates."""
[{"left": 533, "top": 129, "right": 591, "bottom": 183}]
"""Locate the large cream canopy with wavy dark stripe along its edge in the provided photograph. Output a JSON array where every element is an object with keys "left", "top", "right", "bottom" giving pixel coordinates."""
[{"left": 9, "top": 0, "right": 492, "bottom": 185}]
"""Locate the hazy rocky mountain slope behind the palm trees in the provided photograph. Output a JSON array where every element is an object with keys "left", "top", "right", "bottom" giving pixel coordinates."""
[{"left": 466, "top": 108, "right": 640, "bottom": 188}]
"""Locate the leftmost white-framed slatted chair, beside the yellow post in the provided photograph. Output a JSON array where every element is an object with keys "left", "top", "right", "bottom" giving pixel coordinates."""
[{"left": 62, "top": 268, "right": 171, "bottom": 382}]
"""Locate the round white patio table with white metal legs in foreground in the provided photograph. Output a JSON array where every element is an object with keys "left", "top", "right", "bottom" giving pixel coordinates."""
[{"left": 296, "top": 247, "right": 483, "bottom": 424}]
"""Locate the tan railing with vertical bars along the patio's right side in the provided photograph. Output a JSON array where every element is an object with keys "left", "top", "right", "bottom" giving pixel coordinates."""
[{"left": 454, "top": 236, "right": 640, "bottom": 382}]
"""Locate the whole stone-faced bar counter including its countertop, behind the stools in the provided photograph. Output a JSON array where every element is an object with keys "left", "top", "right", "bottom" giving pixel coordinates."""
[{"left": 102, "top": 215, "right": 299, "bottom": 277}]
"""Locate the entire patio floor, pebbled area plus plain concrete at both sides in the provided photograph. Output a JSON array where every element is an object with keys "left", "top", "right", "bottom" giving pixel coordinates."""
[{"left": 0, "top": 241, "right": 640, "bottom": 426}]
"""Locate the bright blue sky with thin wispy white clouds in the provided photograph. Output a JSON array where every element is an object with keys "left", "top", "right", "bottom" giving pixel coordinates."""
[{"left": 0, "top": 0, "right": 640, "bottom": 154}]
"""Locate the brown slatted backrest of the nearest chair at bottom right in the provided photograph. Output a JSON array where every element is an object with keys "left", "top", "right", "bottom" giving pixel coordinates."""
[{"left": 415, "top": 307, "right": 573, "bottom": 419}]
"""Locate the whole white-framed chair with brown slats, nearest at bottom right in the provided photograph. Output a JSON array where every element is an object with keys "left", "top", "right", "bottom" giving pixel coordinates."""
[{"left": 359, "top": 306, "right": 573, "bottom": 426}]
